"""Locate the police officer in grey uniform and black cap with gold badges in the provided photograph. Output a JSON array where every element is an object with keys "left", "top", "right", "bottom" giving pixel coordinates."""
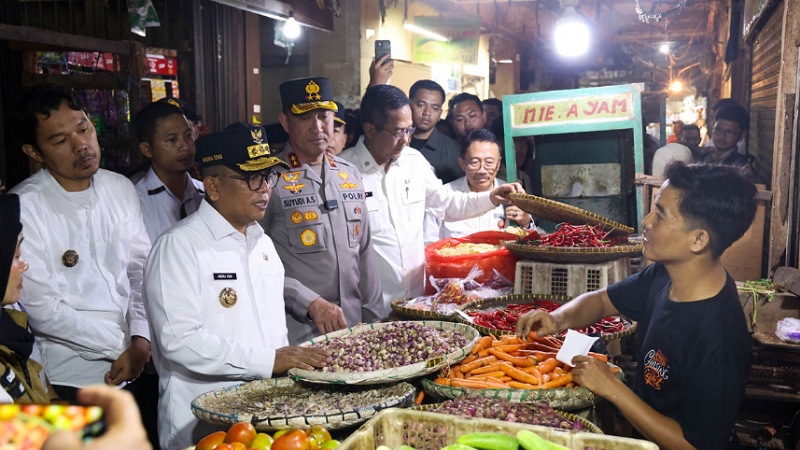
[{"left": 261, "top": 77, "right": 387, "bottom": 345}]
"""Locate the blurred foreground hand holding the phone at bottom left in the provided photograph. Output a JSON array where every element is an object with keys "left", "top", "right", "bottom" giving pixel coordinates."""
[{"left": 42, "top": 385, "right": 152, "bottom": 450}]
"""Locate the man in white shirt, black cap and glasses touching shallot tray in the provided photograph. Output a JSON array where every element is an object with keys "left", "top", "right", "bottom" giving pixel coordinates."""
[{"left": 144, "top": 127, "right": 325, "bottom": 448}]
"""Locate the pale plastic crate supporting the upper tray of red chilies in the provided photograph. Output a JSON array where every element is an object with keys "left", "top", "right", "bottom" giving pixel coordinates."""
[{"left": 514, "top": 258, "right": 631, "bottom": 297}]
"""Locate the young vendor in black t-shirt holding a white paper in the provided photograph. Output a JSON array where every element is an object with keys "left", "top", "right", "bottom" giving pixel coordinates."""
[{"left": 517, "top": 163, "right": 756, "bottom": 449}]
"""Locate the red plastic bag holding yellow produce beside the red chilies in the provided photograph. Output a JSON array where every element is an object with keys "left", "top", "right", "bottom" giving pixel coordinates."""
[{"left": 425, "top": 231, "right": 519, "bottom": 295}]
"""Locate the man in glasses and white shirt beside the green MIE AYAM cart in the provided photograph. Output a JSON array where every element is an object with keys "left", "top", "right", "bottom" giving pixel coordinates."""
[{"left": 425, "top": 128, "right": 533, "bottom": 244}]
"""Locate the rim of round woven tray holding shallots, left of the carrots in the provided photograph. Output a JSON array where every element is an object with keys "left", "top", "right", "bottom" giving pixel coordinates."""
[{"left": 289, "top": 320, "right": 480, "bottom": 384}]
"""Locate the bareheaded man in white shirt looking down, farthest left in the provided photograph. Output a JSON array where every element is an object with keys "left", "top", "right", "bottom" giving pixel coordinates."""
[{"left": 12, "top": 85, "right": 150, "bottom": 402}]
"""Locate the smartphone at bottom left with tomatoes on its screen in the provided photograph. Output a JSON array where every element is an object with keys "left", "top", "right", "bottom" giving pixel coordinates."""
[{"left": 0, "top": 403, "right": 104, "bottom": 450}]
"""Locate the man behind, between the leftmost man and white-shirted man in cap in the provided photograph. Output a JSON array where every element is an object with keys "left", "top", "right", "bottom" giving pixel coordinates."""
[{"left": 133, "top": 98, "right": 203, "bottom": 242}]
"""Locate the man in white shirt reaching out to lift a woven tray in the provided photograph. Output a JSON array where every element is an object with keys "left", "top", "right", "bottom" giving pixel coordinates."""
[{"left": 341, "top": 85, "right": 522, "bottom": 305}]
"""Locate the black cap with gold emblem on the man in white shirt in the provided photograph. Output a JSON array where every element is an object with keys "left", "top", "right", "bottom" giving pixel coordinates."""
[{"left": 194, "top": 126, "right": 289, "bottom": 172}]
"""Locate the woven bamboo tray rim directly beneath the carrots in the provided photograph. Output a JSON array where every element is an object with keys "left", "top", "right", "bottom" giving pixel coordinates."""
[{"left": 422, "top": 363, "right": 625, "bottom": 411}]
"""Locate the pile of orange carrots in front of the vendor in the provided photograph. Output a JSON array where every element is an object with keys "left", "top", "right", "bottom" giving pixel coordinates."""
[{"left": 435, "top": 333, "right": 608, "bottom": 389}]
